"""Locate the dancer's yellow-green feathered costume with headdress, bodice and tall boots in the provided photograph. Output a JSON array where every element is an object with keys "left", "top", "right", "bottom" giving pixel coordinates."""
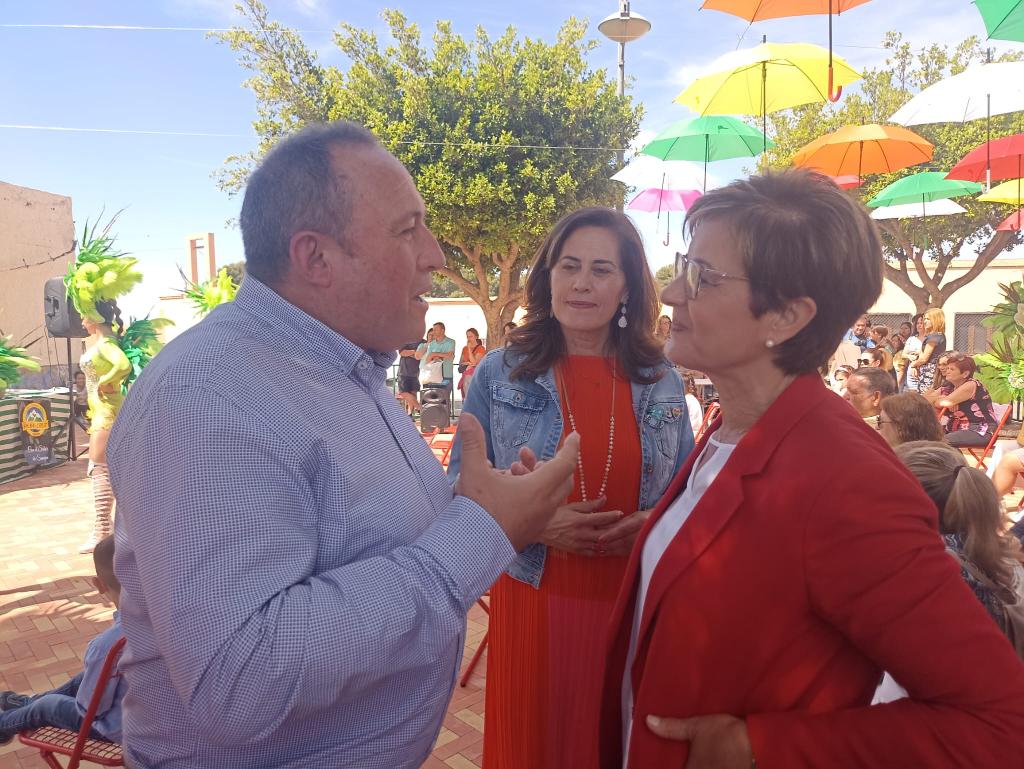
[{"left": 65, "top": 216, "right": 169, "bottom": 553}]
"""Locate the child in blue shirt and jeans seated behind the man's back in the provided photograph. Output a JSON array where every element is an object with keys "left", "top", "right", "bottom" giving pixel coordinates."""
[{"left": 0, "top": 537, "right": 126, "bottom": 744}]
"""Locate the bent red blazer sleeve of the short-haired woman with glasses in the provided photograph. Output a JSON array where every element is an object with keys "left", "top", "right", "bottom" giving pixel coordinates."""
[{"left": 746, "top": 465, "right": 1024, "bottom": 769}]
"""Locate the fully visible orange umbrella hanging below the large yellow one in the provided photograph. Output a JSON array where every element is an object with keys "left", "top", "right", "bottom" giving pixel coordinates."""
[{"left": 793, "top": 123, "right": 935, "bottom": 184}]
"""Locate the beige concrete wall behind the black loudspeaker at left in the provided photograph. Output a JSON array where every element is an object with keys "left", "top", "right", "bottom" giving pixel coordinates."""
[{"left": 0, "top": 181, "right": 75, "bottom": 384}]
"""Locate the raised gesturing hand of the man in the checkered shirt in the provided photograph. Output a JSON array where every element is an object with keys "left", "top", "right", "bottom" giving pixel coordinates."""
[{"left": 455, "top": 413, "right": 580, "bottom": 551}]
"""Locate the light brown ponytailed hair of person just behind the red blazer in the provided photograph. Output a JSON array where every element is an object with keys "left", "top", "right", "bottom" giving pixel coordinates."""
[{"left": 895, "top": 440, "right": 1020, "bottom": 592}]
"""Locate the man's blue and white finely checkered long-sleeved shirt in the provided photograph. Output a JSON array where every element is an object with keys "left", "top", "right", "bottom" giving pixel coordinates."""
[{"left": 109, "top": 277, "right": 515, "bottom": 769}]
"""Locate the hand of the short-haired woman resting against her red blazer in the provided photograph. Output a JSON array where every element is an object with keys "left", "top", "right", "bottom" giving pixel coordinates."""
[{"left": 647, "top": 715, "right": 754, "bottom": 769}]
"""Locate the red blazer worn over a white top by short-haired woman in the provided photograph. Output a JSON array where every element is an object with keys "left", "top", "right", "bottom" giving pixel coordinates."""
[{"left": 601, "top": 375, "right": 1024, "bottom": 769}]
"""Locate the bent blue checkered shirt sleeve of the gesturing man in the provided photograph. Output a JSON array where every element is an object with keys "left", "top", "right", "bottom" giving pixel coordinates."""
[{"left": 111, "top": 389, "right": 515, "bottom": 743}]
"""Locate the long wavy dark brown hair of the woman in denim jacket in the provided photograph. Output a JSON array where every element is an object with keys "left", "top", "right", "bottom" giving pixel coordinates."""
[{"left": 505, "top": 206, "right": 665, "bottom": 384}]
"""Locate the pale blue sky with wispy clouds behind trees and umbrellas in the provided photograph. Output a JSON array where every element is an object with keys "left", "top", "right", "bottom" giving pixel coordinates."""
[{"left": 0, "top": 0, "right": 1015, "bottom": 313}]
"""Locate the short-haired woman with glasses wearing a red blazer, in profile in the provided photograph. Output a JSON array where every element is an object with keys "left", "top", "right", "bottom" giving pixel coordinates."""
[{"left": 601, "top": 171, "right": 1024, "bottom": 769}]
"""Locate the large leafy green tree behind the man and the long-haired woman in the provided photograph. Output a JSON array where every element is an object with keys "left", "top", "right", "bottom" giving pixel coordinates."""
[{"left": 215, "top": 0, "right": 642, "bottom": 346}]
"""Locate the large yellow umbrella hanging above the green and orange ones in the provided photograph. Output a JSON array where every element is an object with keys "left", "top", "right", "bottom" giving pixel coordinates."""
[{"left": 676, "top": 43, "right": 861, "bottom": 148}]
